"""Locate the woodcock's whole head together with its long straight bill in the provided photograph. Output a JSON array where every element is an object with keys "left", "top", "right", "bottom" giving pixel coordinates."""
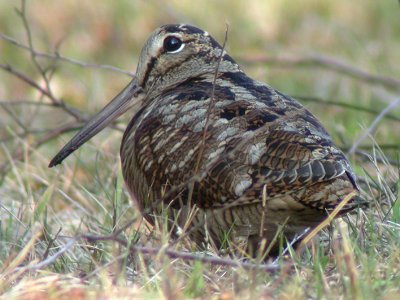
[{"left": 49, "top": 24, "right": 239, "bottom": 167}]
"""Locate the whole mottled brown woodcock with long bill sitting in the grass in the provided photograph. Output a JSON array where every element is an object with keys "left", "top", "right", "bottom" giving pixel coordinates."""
[{"left": 50, "top": 24, "right": 359, "bottom": 255}]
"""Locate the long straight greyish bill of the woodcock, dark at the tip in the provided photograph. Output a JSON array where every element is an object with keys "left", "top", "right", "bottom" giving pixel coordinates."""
[{"left": 49, "top": 79, "right": 143, "bottom": 168}]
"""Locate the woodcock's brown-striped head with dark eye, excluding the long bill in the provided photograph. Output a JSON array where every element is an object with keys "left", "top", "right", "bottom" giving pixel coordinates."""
[{"left": 136, "top": 24, "right": 238, "bottom": 93}]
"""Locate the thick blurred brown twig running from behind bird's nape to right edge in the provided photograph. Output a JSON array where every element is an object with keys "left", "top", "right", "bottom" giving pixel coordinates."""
[{"left": 240, "top": 54, "right": 400, "bottom": 90}]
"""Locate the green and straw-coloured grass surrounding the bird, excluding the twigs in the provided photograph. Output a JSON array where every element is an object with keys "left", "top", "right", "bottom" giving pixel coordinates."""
[{"left": 0, "top": 0, "right": 400, "bottom": 299}]
